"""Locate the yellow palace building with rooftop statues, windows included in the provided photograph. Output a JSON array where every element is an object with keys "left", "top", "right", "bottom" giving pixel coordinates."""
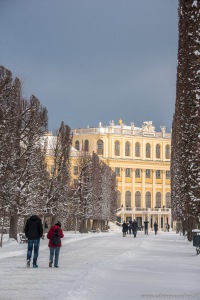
[{"left": 72, "top": 120, "right": 172, "bottom": 230}]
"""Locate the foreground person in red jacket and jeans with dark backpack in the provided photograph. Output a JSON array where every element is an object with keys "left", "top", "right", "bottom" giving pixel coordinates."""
[{"left": 47, "top": 221, "right": 64, "bottom": 268}]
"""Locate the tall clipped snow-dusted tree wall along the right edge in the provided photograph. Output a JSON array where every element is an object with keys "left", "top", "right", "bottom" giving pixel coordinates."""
[{"left": 171, "top": 0, "right": 200, "bottom": 241}]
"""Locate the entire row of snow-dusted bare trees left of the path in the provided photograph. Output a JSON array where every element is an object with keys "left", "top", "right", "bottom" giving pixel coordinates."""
[{"left": 0, "top": 66, "right": 116, "bottom": 245}]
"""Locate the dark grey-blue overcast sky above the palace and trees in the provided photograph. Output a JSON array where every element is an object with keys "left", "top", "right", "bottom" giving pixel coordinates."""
[{"left": 0, "top": 0, "right": 178, "bottom": 132}]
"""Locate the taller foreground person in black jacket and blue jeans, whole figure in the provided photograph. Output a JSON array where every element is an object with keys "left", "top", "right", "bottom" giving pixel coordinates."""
[{"left": 24, "top": 215, "right": 43, "bottom": 268}]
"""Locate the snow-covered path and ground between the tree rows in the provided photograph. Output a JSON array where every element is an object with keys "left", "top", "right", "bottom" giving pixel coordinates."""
[{"left": 0, "top": 232, "right": 200, "bottom": 300}]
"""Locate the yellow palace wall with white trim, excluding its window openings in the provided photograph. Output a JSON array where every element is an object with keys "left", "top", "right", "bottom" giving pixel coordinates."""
[{"left": 73, "top": 121, "right": 171, "bottom": 231}]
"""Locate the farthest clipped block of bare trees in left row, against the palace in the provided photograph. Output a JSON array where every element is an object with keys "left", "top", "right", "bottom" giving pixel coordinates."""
[{"left": 69, "top": 151, "right": 117, "bottom": 232}]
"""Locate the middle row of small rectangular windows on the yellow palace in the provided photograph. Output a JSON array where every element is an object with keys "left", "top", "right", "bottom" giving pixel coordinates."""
[{"left": 115, "top": 167, "right": 171, "bottom": 179}]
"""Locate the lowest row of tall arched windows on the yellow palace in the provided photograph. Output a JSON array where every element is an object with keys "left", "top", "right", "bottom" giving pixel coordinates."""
[{"left": 117, "top": 191, "right": 171, "bottom": 208}]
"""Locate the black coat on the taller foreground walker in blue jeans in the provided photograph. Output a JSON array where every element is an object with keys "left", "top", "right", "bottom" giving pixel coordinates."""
[{"left": 24, "top": 215, "right": 43, "bottom": 240}]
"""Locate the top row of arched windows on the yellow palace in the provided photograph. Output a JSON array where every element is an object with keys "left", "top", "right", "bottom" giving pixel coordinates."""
[{"left": 75, "top": 140, "right": 170, "bottom": 159}]
